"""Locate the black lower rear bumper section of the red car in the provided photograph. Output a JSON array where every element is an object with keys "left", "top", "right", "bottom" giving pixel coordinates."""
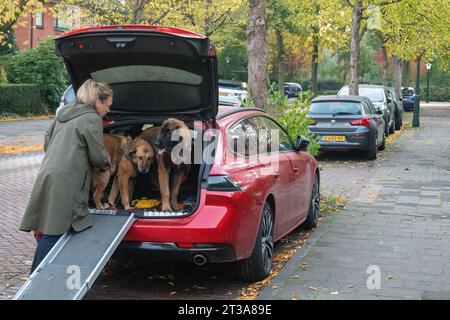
[{"left": 115, "top": 241, "right": 236, "bottom": 263}]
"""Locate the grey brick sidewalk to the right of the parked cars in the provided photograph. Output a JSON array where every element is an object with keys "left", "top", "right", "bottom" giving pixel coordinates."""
[{"left": 258, "top": 105, "right": 450, "bottom": 300}]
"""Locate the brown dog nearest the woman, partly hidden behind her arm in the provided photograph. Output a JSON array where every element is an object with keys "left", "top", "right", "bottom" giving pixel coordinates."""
[{"left": 92, "top": 134, "right": 128, "bottom": 209}]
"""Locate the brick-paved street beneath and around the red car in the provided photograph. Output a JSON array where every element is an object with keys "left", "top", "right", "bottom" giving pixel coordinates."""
[{"left": 0, "top": 105, "right": 446, "bottom": 299}]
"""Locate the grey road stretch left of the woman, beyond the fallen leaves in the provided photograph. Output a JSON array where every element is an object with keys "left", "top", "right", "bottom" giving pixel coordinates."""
[{"left": 0, "top": 120, "right": 52, "bottom": 145}]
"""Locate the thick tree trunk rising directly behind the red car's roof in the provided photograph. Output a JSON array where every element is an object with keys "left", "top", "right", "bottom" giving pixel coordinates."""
[{"left": 247, "top": 0, "right": 269, "bottom": 108}]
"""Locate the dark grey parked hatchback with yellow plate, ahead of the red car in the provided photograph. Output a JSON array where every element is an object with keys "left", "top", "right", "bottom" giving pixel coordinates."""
[{"left": 308, "top": 95, "right": 385, "bottom": 159}]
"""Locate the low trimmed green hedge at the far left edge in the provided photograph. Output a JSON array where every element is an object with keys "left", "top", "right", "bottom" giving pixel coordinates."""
[{"left": 0, "top": 84, "right": 47, "bottom": 116}]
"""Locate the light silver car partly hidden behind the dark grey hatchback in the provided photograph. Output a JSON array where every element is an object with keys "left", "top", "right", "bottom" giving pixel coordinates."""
[{"left": 338, "top": 84, "right": 395, "bottom": 136}]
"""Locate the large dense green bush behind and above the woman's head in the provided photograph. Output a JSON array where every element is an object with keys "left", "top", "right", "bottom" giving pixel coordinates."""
[{"left": 8, "top": 38, "right": 68, "bottom": 108}]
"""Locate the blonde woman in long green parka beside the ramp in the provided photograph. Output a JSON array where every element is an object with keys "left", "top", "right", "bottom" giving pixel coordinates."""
[{"left": 20, "top": 80, "right": 113, "bottom": 273}]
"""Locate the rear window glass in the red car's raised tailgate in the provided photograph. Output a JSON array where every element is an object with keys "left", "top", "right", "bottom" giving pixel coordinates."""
[{"left": 91, "top": 65, "right": 202, "bottom": 85}]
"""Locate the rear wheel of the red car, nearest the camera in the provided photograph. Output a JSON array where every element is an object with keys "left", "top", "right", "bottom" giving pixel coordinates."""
[{"left": 236, "top": 202, "right": 274, "bottom": 282}]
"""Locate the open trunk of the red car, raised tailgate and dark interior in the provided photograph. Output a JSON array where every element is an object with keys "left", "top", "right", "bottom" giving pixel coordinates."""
[{"left": 56, "top": 26, "right": 218, "bottom": 217}]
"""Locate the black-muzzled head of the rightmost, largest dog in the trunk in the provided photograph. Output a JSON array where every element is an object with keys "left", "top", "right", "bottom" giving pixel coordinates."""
[{"left": 154, "top": 118, "right": 192, "bottom": 164}]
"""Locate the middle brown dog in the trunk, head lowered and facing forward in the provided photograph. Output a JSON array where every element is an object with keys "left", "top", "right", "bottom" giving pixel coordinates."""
[{"left": 108, "top": 137, "right": 155, "bottom": 210}]
